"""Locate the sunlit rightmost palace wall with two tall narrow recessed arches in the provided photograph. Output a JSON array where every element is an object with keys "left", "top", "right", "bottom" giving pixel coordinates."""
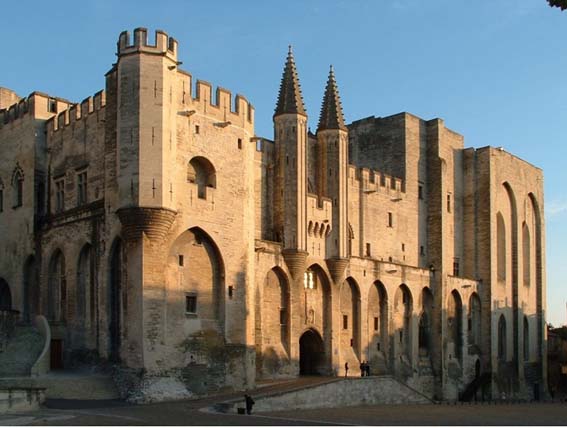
[{"left": 485, "top": 148, "right": 546, "bottom": 396}]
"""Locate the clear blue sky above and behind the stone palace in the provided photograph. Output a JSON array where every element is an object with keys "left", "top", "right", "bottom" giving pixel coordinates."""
[{"left": 4, "top": 0, "right": 567, "bottom": 325}]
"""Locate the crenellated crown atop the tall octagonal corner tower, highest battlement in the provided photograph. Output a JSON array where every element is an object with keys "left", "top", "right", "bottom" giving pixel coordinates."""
[{"left": 116, "top": 27, "right": 177, "bottom": 61}]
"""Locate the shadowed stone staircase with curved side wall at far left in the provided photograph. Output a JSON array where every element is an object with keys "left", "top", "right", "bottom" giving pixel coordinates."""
[{"left": 0, "top": 325, "right": 44, "bottom": 378}]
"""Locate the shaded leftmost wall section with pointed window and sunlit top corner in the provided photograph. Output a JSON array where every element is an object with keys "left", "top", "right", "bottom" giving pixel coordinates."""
[{"left": 0, "top": 92, "right": 68, "bottom": 316}]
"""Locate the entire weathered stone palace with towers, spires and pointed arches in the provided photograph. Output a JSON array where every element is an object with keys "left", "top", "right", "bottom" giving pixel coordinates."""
[{"left": 0, "top": 28, "right": 546, "bottom": 399}]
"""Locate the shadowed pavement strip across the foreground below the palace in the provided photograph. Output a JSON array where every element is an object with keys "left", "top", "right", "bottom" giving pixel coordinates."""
[{"left": 0, "top": 399, "right": 567, "bottom": 425}]
